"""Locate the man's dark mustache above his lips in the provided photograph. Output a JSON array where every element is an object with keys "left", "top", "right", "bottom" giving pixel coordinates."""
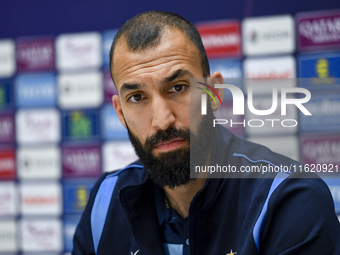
[{"left": 144, "top": 127, "right": 190, "bottom": 150}]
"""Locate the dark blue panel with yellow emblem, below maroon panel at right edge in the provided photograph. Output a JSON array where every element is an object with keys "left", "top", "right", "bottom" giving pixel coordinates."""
[{"left": 298, "top": 52, "right": 340, "bottom": 91}]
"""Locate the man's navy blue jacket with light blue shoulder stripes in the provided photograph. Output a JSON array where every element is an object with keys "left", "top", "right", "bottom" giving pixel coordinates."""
[{"left": 72, "top": 128, "right": 340, "bottom": 255}]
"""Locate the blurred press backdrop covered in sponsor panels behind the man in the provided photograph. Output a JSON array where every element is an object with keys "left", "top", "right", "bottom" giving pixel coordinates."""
[{"left": 0, "top": 0, "right": 340, "bottom": 255}]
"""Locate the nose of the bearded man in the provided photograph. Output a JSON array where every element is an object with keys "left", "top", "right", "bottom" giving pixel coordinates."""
[{"left": 152, "top": 97, "right": 176, "bottom": 130}]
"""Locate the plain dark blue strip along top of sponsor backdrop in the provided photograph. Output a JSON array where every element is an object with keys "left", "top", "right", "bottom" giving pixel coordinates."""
[{"left": 0, "top": 0, "right": 340, "bottom": 38}]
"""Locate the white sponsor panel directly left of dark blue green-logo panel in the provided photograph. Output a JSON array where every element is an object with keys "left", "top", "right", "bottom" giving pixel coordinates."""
[{"left": 16, "top": 109, "right": 60, "bottom": 143}]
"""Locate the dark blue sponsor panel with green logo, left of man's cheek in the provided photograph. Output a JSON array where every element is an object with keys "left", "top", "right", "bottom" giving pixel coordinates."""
[{"left": 63, "top": 110, "right": 99, "bottom": 140}]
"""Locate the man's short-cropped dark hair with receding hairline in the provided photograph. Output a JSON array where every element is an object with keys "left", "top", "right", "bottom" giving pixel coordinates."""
[{"left": 110, "top": 11, "right": 210, "bottom": 82}]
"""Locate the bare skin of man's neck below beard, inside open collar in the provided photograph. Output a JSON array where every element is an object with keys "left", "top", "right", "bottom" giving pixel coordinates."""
[{"left": 163, "top": 178, "right": 207, "bottom": 219}]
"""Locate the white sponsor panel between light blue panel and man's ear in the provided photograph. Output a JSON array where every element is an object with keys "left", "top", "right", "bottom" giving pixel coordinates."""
[{"left": 58, "top": 72, "right": 103, "bottom": 109}]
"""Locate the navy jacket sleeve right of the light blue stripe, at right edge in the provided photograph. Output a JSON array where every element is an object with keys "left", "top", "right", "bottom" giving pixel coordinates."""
[{"left": 260, "top": 174, "right": 340, "bottom": 254}]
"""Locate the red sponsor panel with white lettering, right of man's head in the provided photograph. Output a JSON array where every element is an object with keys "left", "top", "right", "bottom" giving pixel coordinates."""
[{"left": 196, "top": 21, "right": 241, "bottom": 58}]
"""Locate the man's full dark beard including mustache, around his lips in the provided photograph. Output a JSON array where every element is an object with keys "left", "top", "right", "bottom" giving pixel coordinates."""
[{"left": 125, "top": 104, "right": 215, "bottom": 189}]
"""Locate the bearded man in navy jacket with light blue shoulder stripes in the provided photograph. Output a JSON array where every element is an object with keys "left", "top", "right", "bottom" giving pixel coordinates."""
[{"left": 73, "top": 12, "right": 340, "bottom": 255}]
